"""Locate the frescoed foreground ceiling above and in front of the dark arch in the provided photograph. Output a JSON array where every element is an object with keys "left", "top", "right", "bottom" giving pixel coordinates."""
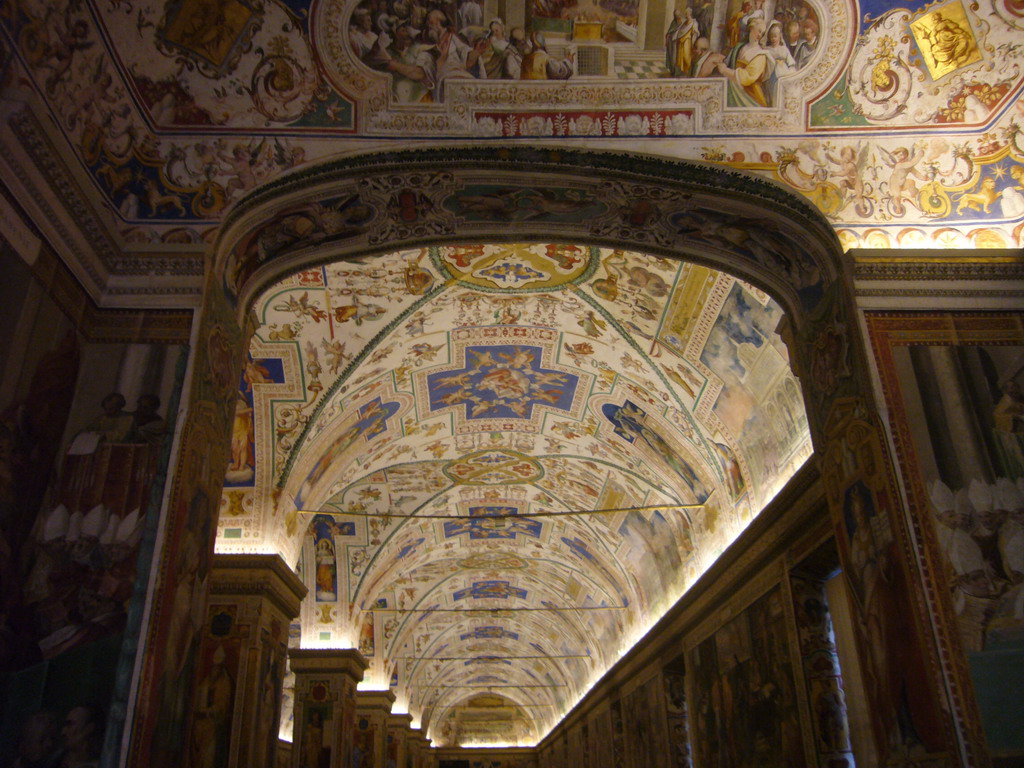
[{"left": 0, "top": 0, "right": 1024, "bottom": 293}]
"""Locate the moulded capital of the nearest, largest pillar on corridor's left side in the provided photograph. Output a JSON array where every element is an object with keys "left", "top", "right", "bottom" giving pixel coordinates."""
[{"left": 210, "top": 555, "right": 308, "bottom": 618}]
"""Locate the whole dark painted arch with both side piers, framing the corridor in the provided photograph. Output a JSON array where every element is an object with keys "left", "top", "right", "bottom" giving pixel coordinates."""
[{"left": 128, "top": 147, "right": 950, "bottom": 768}]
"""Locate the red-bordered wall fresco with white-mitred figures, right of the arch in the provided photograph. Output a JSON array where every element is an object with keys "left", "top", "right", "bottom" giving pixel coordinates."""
[{"left": 868, "top": 313, "right": 1024, "bottom": 766}]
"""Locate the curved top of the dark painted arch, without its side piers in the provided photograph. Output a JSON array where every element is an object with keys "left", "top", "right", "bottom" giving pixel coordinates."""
[{"left": 214, "top": 144, "right": 842, "bottom": 328}]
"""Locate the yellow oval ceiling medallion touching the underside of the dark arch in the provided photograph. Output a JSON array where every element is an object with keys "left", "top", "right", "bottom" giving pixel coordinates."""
[{"left": 430, "top": 244, "right": 600, "bottom": 293}]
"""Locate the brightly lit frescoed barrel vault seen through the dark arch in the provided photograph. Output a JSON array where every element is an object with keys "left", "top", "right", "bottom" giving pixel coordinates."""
[{"left": 217, "top": 244, "right": 811, "bottom": 743}]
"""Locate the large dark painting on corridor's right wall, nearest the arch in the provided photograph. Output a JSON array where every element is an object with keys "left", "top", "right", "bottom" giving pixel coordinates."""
[{"left": 689, "top": 586, "right": 807, "bottom": 768}]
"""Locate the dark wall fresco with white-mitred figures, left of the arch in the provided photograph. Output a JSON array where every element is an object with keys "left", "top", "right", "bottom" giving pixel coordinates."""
[{"left": 0, "top": 252, "right": 177, "bottom": 768}]
